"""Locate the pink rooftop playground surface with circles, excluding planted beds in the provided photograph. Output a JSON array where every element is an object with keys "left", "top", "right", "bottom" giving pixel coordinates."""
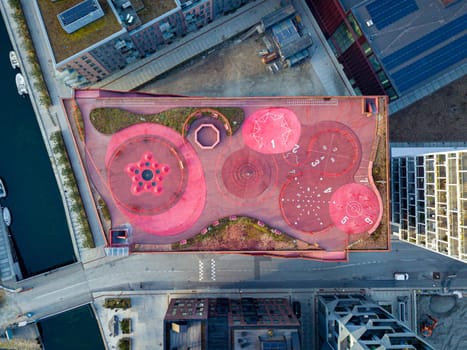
[{"left": 70, "top": 90, "right": 392, "bottom": 260}]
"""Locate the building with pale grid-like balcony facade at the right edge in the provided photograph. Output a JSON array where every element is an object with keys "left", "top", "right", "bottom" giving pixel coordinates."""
[{"left": 391, "top": 150, "right": 467, "bottom": 262}]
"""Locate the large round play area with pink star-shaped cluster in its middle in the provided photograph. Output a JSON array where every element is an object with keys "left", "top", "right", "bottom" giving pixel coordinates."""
[{"left": 107, "top": 135, "right": 187, "bottom": 215}]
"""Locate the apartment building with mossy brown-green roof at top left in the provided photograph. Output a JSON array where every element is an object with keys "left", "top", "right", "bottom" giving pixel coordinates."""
[{"left": 35, "top": 0, "right": 251, "bottom": 85}]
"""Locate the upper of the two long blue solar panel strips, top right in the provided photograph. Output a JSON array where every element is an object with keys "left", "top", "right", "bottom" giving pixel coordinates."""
[{"left": 382, "top": 14, "right": 467, "bottom": 71}]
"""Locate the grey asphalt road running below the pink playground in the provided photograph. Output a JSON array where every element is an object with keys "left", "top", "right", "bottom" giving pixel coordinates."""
[{"left": 10, "top": 241, "right": 467, "bottom": 324}]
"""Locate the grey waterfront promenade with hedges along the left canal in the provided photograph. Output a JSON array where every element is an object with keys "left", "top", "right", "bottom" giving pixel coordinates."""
[{"left": 0, "top": 1, "right": 104, "bottom": 261}]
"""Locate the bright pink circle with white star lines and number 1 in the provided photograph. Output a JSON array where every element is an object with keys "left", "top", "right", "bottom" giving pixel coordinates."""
[{"left": 242, "top": 108, "right": 301, "bottom": 154}]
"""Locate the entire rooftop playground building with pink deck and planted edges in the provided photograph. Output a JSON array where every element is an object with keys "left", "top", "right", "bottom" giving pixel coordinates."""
[{"left": 65, "top": 90, "right": 389, "bottom": 261}]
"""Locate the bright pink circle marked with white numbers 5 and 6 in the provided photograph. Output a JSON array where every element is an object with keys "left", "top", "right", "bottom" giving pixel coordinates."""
[{"left": 329, "top": 183, "right": 381, "bottom": 234}]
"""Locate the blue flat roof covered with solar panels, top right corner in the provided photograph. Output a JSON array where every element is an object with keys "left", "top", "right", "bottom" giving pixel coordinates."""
[{"left": 352, "top": 0, "right": 467, "bottom": 94}]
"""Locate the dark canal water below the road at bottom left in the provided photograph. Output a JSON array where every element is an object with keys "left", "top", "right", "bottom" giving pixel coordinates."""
[{"left": 37, "top": 305, "right": 105, "bottom": 350}]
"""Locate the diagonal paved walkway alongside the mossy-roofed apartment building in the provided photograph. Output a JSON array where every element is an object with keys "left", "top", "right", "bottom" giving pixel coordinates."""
[{"left": 93, "top": 0, "right": 280, "bottom": 90}]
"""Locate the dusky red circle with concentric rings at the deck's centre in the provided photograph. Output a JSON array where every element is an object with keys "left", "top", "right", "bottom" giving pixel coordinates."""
[{"left": 221, "top": 148, "right": 273, "bottom": 199}]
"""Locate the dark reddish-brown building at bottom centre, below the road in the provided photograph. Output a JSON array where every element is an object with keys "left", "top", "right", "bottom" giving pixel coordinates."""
[{"left": 164, "top": 298, "right": 300, "bottom": 350}]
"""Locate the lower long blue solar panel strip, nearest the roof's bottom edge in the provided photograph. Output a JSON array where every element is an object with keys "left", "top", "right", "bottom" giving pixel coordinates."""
[{"left": 392, "top": 34, "right": 467, "bottom": 93}]
